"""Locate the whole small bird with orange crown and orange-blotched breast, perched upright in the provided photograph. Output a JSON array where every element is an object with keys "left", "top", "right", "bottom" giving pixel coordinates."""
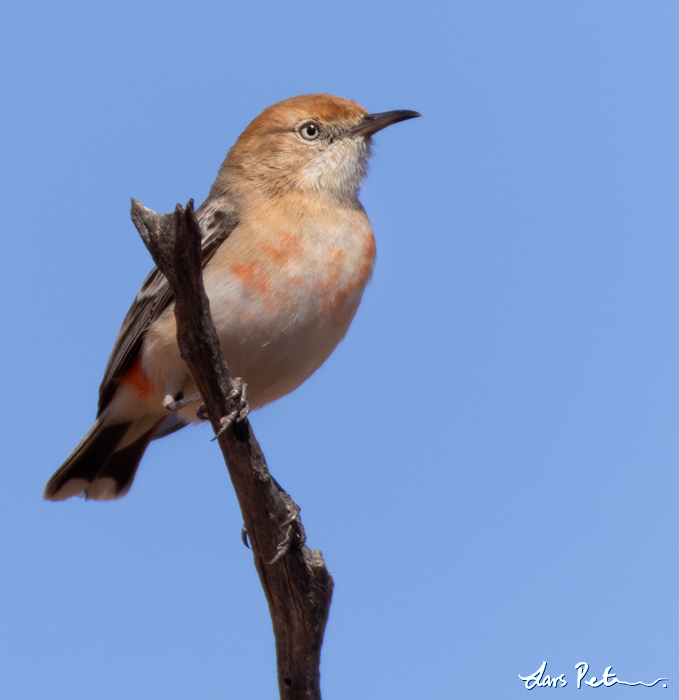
[{"left": 43, "top": 94, "right": 421, "bottom": 501}]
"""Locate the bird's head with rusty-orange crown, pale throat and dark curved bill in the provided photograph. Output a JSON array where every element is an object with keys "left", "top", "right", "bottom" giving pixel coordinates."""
[{"left": 222, "top": 94, "right": 420, "bottom": 204}]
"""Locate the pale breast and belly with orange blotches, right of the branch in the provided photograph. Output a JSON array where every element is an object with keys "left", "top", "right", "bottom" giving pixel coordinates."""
[{"left": 194, "top": 212, "right": 375, "bottom": 406}]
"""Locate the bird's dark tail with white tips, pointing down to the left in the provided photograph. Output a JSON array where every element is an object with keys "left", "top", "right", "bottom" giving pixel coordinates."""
[{"left": 42, "top": 416, "right": 163, "bottom": 501}]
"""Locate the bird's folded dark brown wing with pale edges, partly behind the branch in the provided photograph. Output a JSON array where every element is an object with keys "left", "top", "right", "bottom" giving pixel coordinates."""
[{"left": 97, "top": 199, "right": 238, "bottom": 416}]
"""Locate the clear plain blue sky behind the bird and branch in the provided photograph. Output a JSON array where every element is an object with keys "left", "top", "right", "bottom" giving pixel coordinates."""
[{"left": 0, "top": 0, "right": 679, "bottom": 700}]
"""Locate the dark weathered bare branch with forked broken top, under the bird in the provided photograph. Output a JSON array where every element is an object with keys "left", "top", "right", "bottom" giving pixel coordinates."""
[{"left": 131, "top": 199, "right": 333, "bottom": 700}]
